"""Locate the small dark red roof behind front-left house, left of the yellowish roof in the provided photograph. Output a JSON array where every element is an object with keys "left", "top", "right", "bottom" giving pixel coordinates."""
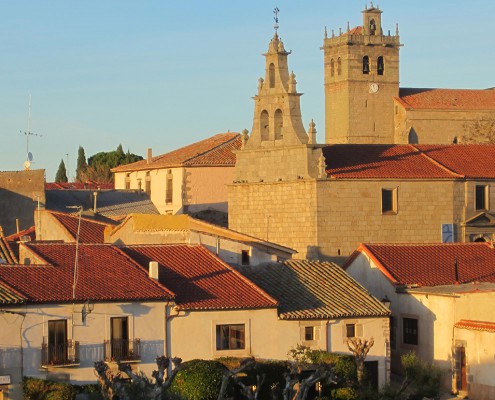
[{"left": 50, "top": 212, "right": 117, "bottom": 243}]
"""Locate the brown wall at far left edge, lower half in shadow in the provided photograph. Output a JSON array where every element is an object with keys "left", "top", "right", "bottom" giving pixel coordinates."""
[{"left": 0, "top": 169, "right": 46, "bottom": 235}]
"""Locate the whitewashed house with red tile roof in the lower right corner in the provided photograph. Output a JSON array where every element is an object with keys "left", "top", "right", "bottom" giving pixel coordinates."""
[{"left": 344, "top": 243, "right": 495, "bottom": 399}]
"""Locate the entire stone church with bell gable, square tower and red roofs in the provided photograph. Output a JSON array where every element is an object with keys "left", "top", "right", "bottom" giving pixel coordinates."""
[{"left": 228, "top": 6, "right": 495, "bottom": 262}]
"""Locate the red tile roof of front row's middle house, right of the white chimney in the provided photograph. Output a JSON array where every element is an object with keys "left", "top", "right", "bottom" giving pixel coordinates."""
[{"left": 118, "top": 244, "right": 277, "bottom": 310}]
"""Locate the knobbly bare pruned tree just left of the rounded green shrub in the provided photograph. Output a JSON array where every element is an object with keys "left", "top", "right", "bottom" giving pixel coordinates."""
[{"left": 95, "top": 356, "right": 182, "bottom": 400}]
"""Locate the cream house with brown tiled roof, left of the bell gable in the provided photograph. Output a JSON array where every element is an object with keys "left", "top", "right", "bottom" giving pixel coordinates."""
[{"left": 112, "top": 133, "right": 240, "bottom": 215}]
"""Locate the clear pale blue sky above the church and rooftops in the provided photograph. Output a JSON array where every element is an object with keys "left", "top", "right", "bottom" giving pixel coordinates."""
[{"left": 0, "top": 0, "right": 495, "bottom": 182}]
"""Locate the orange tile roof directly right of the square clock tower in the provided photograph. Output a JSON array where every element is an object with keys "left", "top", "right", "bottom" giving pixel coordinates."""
[{"left": 397, "top": 88, "right": 495, "bottom": 110}]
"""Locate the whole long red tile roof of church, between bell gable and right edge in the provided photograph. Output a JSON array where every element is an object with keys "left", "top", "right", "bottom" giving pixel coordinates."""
[{"left": 323, "top": 144, "right": 495, "bottom": 179}]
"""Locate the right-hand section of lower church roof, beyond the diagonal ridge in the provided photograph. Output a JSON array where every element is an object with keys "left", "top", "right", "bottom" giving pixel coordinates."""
[{"left": 415, "top": 144, "right": 495, "bottom": 179}]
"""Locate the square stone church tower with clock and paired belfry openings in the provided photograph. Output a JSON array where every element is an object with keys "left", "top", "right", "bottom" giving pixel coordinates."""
[{"left": 322, "top": 4, "right": 401, "bottom": 144}]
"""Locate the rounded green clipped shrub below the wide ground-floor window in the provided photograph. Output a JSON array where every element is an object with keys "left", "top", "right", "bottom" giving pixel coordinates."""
[{"left": 170, "top": 360, "right": 226, "bottom": 400}]
